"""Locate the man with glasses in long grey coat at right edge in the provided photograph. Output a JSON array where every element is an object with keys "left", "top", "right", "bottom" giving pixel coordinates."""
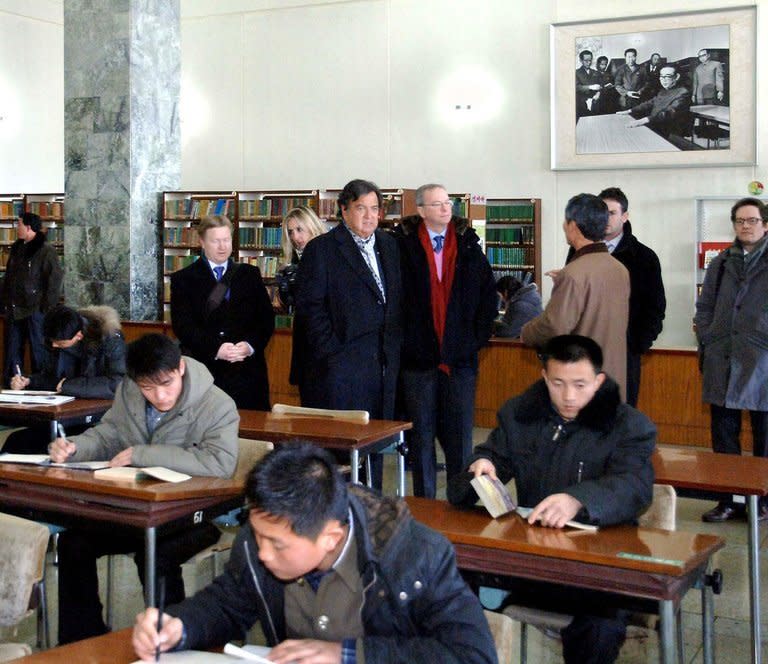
[{"left": 693, "top": 198, "right": 768, "bottom": 522}]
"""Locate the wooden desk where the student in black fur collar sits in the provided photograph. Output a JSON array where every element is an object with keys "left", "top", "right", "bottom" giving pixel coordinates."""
[{"left": 406, "top": 497, "right": 725, "bottom": 662}]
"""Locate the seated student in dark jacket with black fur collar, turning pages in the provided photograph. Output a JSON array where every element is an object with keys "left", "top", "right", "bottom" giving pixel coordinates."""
[{"left": 447, "top": 335, "right": 656, "bottom": 663}]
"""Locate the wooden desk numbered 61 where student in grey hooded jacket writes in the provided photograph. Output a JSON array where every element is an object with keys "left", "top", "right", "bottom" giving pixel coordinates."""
[{"left": 0, "top": 463, "right": 243, "bottom": 606}]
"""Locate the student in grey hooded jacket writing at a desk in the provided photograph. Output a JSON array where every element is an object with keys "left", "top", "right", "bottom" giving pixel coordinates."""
[{"left": 50, "top": 334, "right": 240, "bottom": 643}]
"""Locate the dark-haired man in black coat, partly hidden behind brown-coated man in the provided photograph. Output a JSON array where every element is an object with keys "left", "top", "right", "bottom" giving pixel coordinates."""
[{"left": 598, "top": 187, "right": 667, "bottom": 406}]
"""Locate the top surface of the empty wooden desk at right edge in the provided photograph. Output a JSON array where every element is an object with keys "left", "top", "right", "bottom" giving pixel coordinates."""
[{"left": 653, "top": 447, "right": 768, "bottom": 496}]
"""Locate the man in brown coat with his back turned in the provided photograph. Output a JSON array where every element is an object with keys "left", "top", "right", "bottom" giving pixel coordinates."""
[{"left": 520, "top": 194, "right": 629, "bottom": 401}]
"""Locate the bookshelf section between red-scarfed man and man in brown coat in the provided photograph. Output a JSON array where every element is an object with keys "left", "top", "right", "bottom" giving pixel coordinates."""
[{"left": 485, "top": 198, "right": 541, "bottom": 291}]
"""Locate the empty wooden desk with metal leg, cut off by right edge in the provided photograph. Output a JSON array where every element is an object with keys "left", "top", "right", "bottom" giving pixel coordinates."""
[{"left": 653, "top": 448, "right": 768, "bottom": 664}]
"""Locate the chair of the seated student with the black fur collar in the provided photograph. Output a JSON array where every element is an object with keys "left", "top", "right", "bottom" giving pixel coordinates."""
[{"left": 503, "top": 484, "right": 685, "bottom": 664}]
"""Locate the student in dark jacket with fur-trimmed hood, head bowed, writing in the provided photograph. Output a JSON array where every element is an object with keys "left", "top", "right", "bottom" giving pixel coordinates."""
[{"left": 2, "top": 305, "right": 125, "bottom": 454}]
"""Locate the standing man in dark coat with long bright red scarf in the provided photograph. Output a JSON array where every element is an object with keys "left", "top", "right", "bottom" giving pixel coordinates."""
[{"left": 396, "top": 184, "right": 497, "bottom": 498}]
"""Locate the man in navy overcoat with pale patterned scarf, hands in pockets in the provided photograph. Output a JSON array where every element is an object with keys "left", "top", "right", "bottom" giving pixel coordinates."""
[{"left": 296, "top": 180, "right": 403, "bottom": 488}]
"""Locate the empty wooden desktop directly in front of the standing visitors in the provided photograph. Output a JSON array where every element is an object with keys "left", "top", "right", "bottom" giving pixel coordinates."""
[{"left": 239, "top": 410, "right": 413, "bottom": 450}]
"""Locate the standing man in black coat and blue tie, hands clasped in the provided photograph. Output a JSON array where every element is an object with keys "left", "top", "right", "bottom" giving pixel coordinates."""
[{"left": 171, "top": 215, "right": 275, "bottom": 410}]
